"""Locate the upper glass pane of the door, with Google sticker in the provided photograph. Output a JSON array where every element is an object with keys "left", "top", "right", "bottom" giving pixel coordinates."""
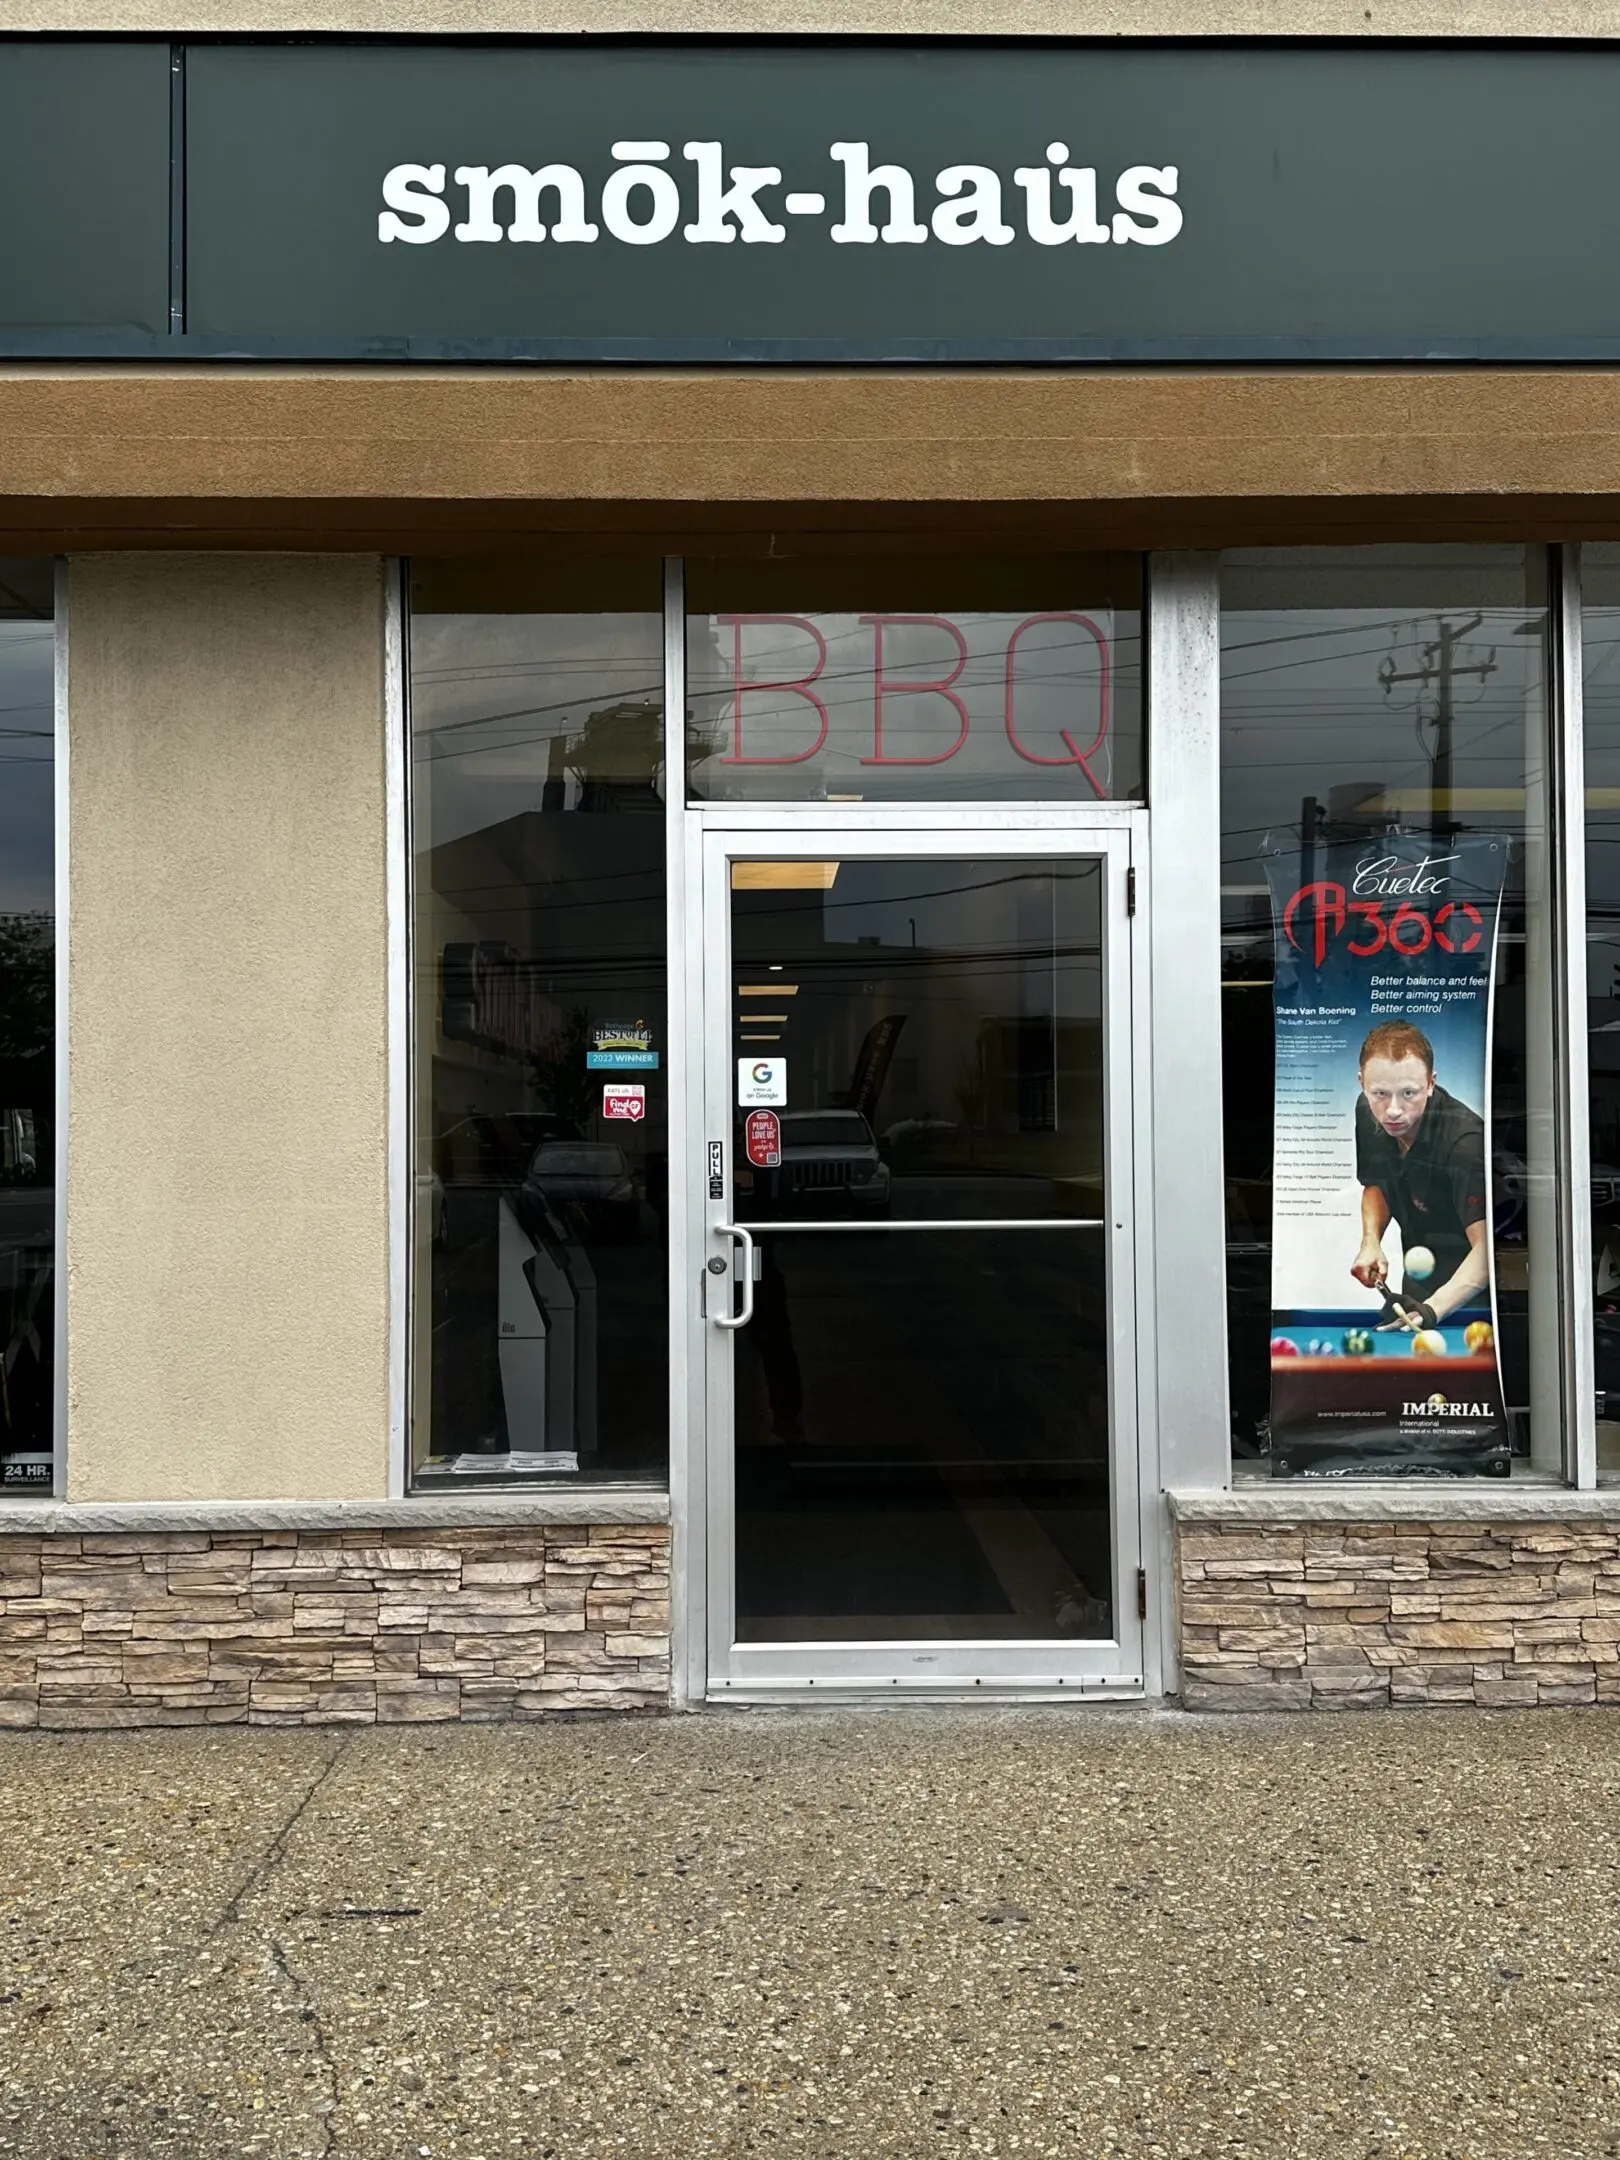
[{"left": 730, "top": 853, "right": 1106, "bottom": 1223}]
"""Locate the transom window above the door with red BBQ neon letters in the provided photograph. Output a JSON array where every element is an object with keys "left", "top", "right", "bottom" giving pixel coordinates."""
[{"left": 687, "top": 555, "right": 1143, "bottom": 804}]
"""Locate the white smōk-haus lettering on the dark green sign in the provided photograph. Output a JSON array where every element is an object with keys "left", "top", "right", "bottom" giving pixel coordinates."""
[{"left": 376, "top": 143, "right": 1184, "bottom": 248}]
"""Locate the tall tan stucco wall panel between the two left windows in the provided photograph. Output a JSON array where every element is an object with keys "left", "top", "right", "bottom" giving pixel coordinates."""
[{"left": 67, "top": 553, "right": 389, "bottom": 1499}]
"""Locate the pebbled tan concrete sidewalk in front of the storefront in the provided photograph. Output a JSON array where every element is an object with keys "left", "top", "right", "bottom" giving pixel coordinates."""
[{"left": 0, "top": 1711, "right": 1620, "bottom": 2160}]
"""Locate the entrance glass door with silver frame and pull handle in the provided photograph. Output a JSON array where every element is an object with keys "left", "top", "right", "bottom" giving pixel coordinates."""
[{"left": 702, "top": 821, "right": 1140, "bottom": 1696}]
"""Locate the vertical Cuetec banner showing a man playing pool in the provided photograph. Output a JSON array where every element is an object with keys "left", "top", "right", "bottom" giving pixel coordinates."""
[{"left": 1270, "top": 834, "right": 1510, "bottom": 1477}]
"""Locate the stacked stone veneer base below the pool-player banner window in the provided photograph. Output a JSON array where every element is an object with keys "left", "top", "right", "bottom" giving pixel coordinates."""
[{"left": 1175, "top": 1495, "right": 1620, "bottom": 1711}]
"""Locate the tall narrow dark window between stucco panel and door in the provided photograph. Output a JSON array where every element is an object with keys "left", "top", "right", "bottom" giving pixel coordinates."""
[{"left": 410, "top": 562, "right": 670, "bottom": 1488}]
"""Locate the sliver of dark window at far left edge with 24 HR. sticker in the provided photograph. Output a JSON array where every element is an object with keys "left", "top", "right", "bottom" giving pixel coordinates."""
[{"left": 0, "top": 559, "right": 56, "bottom": 1495}]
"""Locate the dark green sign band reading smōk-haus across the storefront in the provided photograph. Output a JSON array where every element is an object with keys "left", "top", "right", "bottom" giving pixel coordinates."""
[{"left": 22, "top": 37, "right": 1620, "bottom": 363}]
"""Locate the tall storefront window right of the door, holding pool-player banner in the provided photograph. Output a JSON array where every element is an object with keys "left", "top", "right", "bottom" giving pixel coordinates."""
[{"left": 1220, "top": 546, "right": 1562, "bottom": 1480}]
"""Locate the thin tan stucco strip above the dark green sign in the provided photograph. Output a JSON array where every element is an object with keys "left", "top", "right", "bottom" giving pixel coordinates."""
[{"left": 12, "top": 0, "right": 1620, "bottom": 37}]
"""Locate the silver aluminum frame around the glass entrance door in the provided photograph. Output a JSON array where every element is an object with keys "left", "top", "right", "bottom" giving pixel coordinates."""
[{"left": 678, "top": 804, "right": 1151, "bottom": 1702}]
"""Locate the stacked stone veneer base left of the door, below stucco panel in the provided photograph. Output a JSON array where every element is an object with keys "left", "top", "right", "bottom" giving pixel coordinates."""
[{"left": 0, "top": 1523, "right": 670, "bottom": 1728}]
